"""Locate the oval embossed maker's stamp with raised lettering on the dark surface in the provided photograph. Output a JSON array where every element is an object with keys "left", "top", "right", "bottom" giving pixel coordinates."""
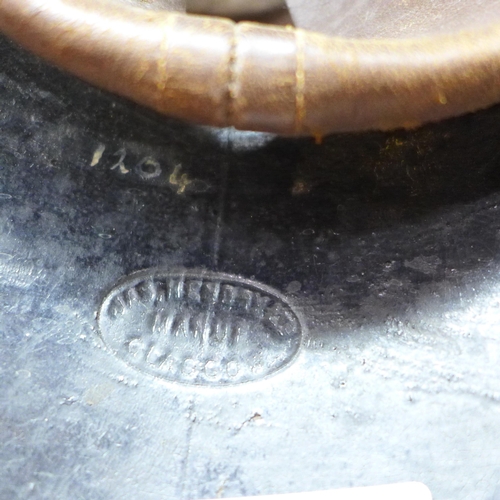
[{"left": 98, "top": 269, "right": 303, "bottom": 386}]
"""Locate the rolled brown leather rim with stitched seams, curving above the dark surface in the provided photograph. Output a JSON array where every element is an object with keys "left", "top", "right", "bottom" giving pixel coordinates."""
[{"left": 0, "top": 0, "right": 500, "bottom": 136}]
